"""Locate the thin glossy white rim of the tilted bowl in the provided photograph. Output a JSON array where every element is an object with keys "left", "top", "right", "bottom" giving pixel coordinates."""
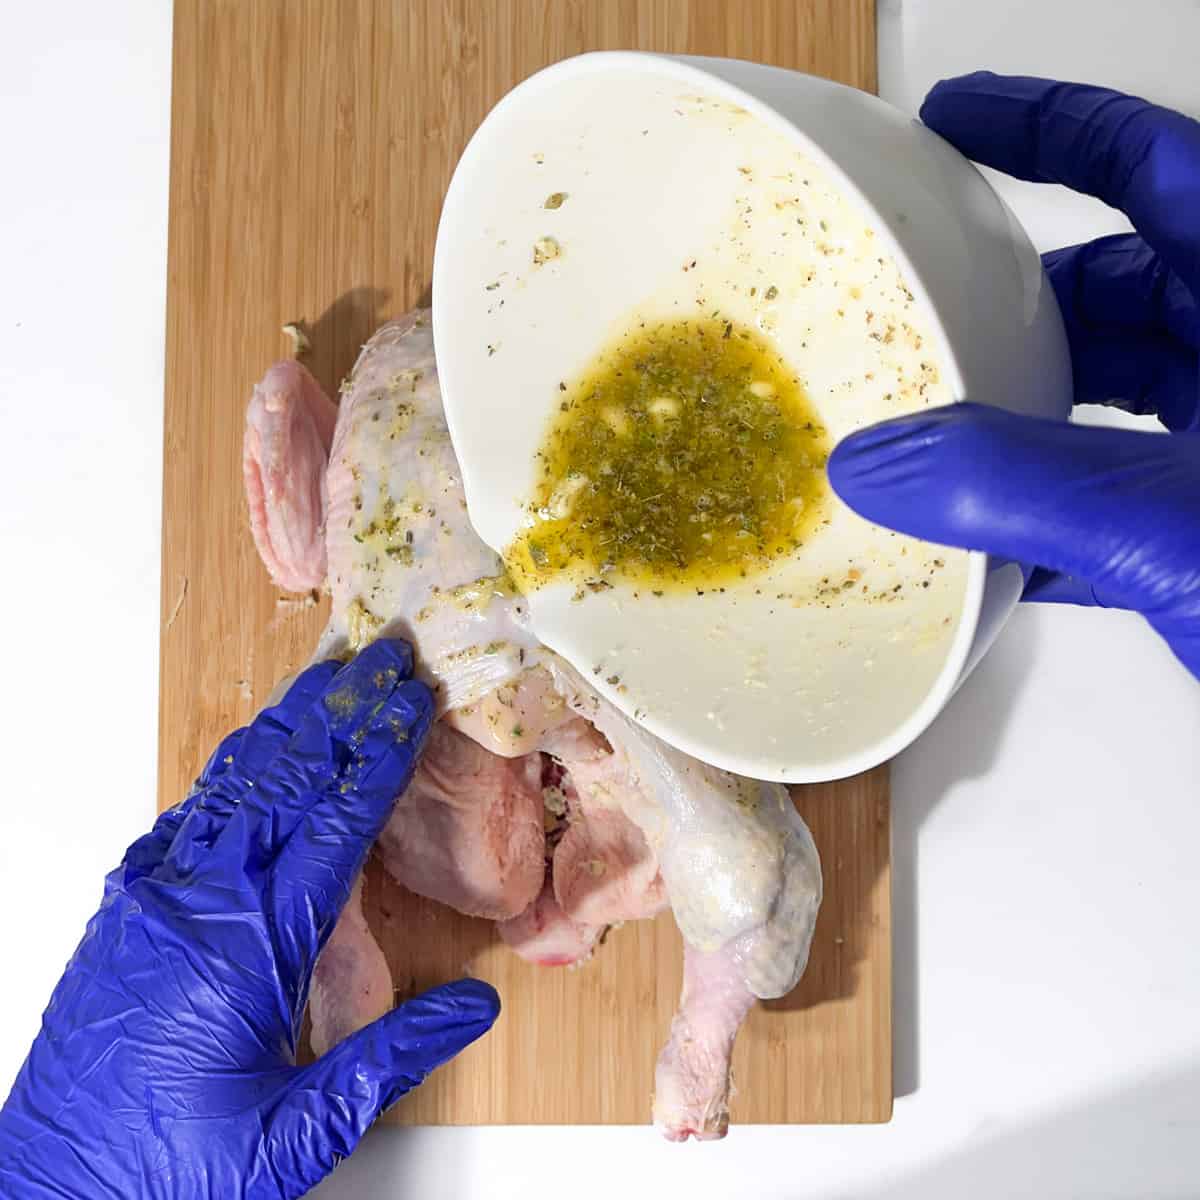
[{"left": 432, "top": 50, "right": 989, "bottom": 784}]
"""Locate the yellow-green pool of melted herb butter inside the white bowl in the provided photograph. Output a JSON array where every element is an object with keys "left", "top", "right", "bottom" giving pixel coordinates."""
[{"left": 505, "top": 314, "right": 828, "bottom": 590}]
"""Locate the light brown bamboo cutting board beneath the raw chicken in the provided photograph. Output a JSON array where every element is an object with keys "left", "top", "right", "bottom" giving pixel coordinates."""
[{"left": 158, "top": 0, "right": 892, "bottom": 1124}]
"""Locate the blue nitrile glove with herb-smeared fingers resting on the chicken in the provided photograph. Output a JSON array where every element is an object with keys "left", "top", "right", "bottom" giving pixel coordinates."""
[{"left": 0, "top": 642, "right": 498, "bottom": 1200}]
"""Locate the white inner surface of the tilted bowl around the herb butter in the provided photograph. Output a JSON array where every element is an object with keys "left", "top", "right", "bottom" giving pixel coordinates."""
[{"left": 434, "top": 54, "right": 983, "bottom": 782}]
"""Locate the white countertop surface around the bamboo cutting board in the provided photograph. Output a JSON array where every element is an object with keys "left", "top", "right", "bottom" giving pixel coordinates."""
[{"left": 0, "top": 0, "right": 1200, "bottom": 1200}]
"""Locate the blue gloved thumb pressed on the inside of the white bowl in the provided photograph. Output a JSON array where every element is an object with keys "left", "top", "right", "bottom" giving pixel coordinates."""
[{"left": 829, "top": 404, "right": 1200, "bottom": 623}]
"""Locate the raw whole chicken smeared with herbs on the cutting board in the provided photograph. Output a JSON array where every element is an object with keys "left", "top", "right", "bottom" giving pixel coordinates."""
[{"left": 244, "top": 312, "right": 821, "bottom": 1141}]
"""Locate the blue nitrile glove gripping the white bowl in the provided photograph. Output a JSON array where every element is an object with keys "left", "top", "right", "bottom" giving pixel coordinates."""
[{"left": 829, "top": 72, "right": 1200, "bottom": 676}]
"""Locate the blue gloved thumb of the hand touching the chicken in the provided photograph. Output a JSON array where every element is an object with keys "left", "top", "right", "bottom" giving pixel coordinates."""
[{"left": 268, "top": 979, "right": 500, "bottom": 1187}]
